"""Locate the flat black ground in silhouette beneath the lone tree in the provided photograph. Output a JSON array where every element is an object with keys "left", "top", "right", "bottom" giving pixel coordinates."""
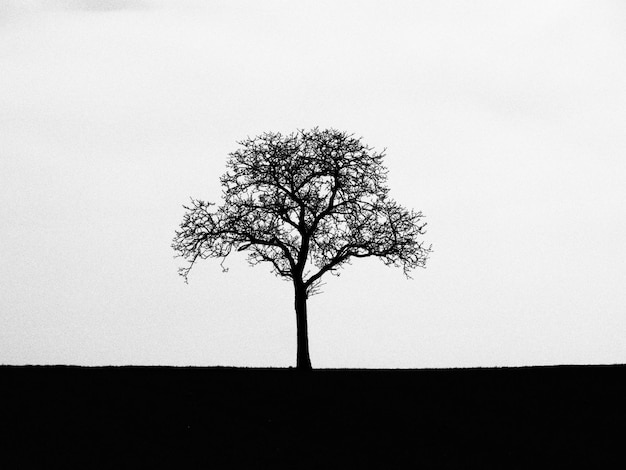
[{"left": 0, "top": 366, "right": 626, "bottom": 468}]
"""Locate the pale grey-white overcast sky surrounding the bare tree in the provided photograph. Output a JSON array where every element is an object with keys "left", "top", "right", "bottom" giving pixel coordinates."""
[{"left": 0, "top": 0, "right": 626, "bottom": 368}]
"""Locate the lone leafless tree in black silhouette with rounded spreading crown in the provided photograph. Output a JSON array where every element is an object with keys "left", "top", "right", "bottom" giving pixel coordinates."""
[{"left": 172, "top": 128, "right": 431, "bottom": 369}]
